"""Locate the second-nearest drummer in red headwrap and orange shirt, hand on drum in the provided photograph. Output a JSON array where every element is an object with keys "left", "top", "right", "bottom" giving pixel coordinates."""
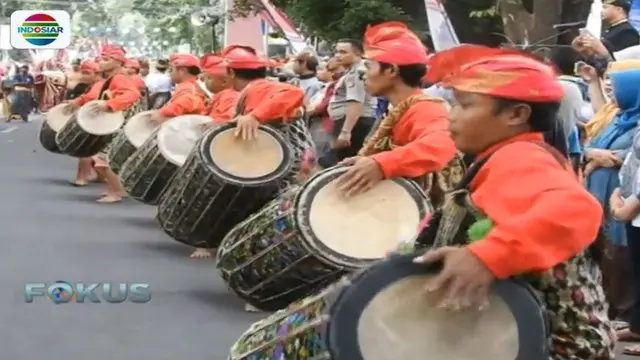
[{"left": 338, "top": 22, "right": 456, "bottom": 196}]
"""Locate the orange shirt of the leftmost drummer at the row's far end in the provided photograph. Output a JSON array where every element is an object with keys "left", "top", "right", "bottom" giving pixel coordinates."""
[{"left": 73, "top": 74, "right": 141, "bottom": 111}]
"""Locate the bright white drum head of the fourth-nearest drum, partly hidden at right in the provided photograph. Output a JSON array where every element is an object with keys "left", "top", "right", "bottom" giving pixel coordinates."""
[{"left": 157, "top": 115, "right": 213, "bottom": 166}]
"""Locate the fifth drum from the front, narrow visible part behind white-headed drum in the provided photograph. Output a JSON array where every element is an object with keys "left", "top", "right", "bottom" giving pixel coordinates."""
[{"left": 107, "top": 111, "right": 160, "bottom": 174}]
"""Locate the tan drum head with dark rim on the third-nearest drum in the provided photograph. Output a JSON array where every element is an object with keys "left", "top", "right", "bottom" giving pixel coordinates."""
[{"left": 201, "top": 124, "right": 291, "bottom": 186}]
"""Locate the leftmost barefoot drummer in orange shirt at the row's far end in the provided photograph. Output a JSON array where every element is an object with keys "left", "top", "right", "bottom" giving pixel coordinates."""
[{"left": 69, "top": 45, "right": 141, "bottom": 203}]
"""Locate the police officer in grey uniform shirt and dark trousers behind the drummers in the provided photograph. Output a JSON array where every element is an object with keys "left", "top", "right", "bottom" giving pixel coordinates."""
[{"left": 318, "top": 39, "right": 377, "bottom": 167}]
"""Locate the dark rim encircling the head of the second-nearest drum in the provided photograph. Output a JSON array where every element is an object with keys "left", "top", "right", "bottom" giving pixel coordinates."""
[{"left": 293, "top": 165, "right": 434, "bottom": 270}]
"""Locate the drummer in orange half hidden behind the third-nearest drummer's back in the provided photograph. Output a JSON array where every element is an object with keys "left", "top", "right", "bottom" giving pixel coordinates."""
[{"left": 201, "top": 55, "right": 240, "bottom": 123}]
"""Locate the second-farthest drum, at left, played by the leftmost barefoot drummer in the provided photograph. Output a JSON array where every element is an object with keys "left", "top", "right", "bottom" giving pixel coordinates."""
[{"left": 56, "top": 100, "right": 125, "bottom": 158}]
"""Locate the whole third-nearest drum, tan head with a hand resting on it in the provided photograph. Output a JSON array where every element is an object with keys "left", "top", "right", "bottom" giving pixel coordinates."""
[{"left": 157, "top": 124, "right": 293, "bottom": 248}]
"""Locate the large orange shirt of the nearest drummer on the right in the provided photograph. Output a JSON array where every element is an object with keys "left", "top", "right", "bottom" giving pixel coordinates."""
[{"left": 467, "top": 133, "right": 603, "bottom": 279}]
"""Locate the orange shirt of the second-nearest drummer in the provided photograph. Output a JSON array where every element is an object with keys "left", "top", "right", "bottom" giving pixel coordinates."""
[{"left": 372, "top": 97, "right": 456, "bottom": 178}]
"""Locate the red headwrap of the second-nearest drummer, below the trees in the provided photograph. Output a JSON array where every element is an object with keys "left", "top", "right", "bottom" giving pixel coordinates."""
[{"left": 364, "top": 21, "right": 427, "bottom": 65}]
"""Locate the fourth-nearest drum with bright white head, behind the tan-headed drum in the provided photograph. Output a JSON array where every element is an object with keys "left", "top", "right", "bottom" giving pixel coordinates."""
[{"left": 120, "top": 115, "right": 213, "bottom": 205}]
